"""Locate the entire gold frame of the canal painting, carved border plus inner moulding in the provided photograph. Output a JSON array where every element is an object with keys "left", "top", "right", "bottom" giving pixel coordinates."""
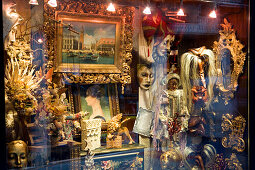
[{"left": 44, "top": 0, "right": 134, "bottom": 90}]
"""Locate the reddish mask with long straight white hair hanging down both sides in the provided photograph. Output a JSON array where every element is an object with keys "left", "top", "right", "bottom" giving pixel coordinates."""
[{"left": 181, "top": 46, "right": 217, "bottom": 112}]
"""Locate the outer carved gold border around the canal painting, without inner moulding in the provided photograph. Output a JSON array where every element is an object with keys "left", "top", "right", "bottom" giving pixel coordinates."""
[{"left": 44, "top": 0, "right": 134, "bottom": 92}]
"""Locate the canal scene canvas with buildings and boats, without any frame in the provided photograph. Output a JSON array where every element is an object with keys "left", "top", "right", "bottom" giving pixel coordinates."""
[{"left": 62, "top": 21, "right": 116, "bottom": 64}]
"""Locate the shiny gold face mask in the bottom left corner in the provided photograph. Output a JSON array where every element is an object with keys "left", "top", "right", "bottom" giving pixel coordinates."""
[{"left": 8, "top": 140, "right": 28, "bottom": 168}]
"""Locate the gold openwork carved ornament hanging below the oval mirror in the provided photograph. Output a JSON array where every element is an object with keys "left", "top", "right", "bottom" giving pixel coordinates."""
[{"left": 221, "top": 114, "right": 246, "bottom": 152}]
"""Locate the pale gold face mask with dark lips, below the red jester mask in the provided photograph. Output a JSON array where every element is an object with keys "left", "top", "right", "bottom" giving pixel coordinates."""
[{"left": 137, "top": 66, "right": 155, "bottom": 90}]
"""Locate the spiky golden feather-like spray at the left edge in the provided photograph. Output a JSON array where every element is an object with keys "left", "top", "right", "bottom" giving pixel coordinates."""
[{"left": 4, "top": 58, "right": 42, "bottom": 114}]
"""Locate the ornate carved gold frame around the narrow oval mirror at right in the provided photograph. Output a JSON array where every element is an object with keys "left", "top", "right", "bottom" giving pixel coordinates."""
[{"left": 213, "top": 18, "right": 246, "bottom": 104}]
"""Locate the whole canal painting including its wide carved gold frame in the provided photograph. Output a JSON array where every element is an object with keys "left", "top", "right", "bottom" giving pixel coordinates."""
[{"left": 44, "top": 0, "right": 135, "bottom": 89}]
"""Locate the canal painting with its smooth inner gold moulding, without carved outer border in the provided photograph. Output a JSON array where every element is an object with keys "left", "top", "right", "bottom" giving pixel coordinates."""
[{"left": 56, "top": 12, "right": 124, "bottom": 73}]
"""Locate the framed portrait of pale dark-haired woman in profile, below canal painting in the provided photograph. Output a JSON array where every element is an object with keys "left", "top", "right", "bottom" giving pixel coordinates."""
[{"left": 69, "top": 84, "right": 119, "bottom": 122}]
